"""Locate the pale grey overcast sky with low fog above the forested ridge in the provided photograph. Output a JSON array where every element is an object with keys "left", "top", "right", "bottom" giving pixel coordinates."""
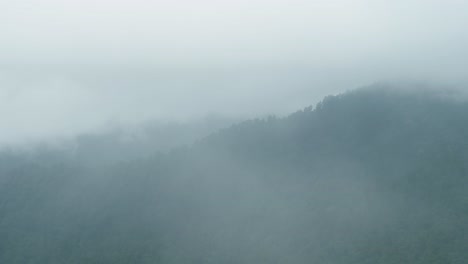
[{"left": 0, "top": 0, "right": 468, "bottom": 143}]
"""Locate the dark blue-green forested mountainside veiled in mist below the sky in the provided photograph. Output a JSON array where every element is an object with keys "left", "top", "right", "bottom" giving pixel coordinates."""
[{"left": 0, "top": 85, "right": 468, "bottom": 264}]
